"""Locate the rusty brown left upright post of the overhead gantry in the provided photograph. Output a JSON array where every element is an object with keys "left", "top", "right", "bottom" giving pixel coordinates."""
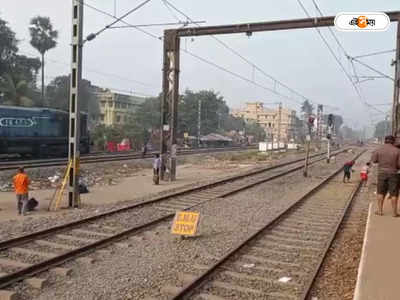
[{"left": 160, "top": 30, "right": 179, "bottom": 181}]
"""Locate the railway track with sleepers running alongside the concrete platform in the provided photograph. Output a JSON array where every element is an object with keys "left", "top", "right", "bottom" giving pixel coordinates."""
[{"left": 165, "top": 152, "right": 364, "bottom": 300}]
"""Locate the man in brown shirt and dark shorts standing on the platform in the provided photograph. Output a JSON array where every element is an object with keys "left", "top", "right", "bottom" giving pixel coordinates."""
[{"left": 371, "top": 135, "right": 400, "bottom": 217}]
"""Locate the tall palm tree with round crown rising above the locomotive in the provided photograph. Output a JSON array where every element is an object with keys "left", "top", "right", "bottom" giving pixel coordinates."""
[{"left": 29, "top": 16, "right": 58, "bottom": 102}]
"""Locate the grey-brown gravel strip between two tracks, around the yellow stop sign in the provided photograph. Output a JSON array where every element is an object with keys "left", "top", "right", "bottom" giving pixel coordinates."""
[{"left": 17, "top": 149, "right": 360, "bottom": 300}]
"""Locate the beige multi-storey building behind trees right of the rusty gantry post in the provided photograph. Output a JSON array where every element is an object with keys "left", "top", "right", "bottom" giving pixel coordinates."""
[{"left": 232, "top": 102, "right": 296, "bottom": 142}]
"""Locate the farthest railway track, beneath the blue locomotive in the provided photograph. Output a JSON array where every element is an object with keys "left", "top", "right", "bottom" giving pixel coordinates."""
[{"left": 0, "top": 146, "right": 256, "bottom": 171}]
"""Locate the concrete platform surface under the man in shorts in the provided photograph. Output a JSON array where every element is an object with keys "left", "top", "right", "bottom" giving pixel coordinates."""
[{"left": 354, "top": 200, "right": 400, "bottom": 300}]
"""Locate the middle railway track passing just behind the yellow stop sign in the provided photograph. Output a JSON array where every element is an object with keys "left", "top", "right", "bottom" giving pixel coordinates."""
[{"left": 0, "top": 150, "right": 345, "bottom": 289}]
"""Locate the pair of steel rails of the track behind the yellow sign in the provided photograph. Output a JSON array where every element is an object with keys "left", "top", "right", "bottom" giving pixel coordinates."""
[{"left": 0, "top": 149, "right": 346, "bottom": 288}]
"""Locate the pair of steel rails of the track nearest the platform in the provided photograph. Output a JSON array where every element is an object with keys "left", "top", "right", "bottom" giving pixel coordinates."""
[{"left": 171, "top": 150, "right": 366, "bottom": 300}]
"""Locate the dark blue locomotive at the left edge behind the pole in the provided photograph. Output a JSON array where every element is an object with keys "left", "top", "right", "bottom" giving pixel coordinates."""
[{"left": 0, "top": 105, "right": 90, "bottom": 157}]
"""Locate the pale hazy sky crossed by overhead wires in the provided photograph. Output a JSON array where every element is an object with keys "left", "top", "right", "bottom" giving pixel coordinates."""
[{"left": 0, "top": 0, "right": 400, "bottom": 127}]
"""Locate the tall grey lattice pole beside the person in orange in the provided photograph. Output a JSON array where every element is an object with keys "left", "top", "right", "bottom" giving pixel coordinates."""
[{"left": 68, "top": 0, "right": 83, "bottom": 207}]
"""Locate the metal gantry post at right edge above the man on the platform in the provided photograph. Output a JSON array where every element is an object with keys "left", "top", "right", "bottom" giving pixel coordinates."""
[{"left": 392, "top": 19, "right": 400, "bottom": 136}]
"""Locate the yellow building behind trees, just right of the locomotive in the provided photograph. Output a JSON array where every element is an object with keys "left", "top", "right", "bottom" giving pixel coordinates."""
[{"left": 93, "top": 89, "right": 146, "bottom": 126}]
